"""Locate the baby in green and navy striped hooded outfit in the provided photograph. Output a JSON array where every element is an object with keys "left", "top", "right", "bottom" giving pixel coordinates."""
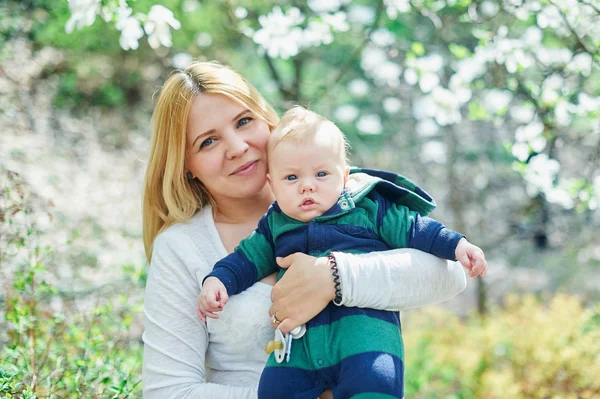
[{"left": 198, "top": 107, "right": 487, "bottom": 398}]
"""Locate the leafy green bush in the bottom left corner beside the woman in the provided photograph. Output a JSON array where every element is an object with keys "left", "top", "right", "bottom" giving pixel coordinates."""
[{"left": 0, "top": 172, "right": 142, "bottom": 399}]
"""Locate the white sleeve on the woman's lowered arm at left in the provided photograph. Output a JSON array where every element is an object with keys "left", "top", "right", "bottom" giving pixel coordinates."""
[{"left": 142, "top": 235, "right": 257, "bottom": 399}]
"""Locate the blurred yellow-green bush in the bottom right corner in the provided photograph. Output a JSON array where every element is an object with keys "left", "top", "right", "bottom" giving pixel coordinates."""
[{"left": 404, "top": 294, "right": 600, "bottom": 399}]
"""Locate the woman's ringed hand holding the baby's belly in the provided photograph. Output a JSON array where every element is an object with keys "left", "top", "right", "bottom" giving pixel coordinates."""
[{"left": 269, "top": 252, "right": 335, "bottom": 334}]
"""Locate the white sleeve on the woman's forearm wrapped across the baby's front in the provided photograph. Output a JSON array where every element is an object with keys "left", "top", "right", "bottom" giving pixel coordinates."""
[{"left": 334, "top": 249, "right": 467, "bottom": 311}]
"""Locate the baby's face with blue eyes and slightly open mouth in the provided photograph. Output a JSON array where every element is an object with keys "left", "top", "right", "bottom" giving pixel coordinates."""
[{"left": 268, "top": 141, "right": 348, "bottom": 222}]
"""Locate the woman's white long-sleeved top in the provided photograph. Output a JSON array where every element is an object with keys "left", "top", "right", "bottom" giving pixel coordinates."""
[{"left": 142, "top": 207, "right": 466, "bottom": 399}]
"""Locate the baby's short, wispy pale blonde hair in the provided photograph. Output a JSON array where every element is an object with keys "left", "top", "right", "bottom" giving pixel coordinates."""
[{"left": 267, "top": 105, "right": 350, "bottom": 163}]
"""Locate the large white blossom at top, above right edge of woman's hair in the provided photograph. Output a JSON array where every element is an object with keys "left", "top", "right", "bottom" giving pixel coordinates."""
[{"left": 252, "top": 6, "right": 304, "bottom": 59}]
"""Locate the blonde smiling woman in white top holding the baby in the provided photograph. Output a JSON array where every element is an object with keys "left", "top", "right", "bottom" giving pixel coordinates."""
[{"left": 143, "top": 63, "right": 466, "bottom": 399}]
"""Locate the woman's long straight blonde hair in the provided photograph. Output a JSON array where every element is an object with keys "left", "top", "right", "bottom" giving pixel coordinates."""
[{"left": 142, "top": 62, "right": 279, "bottom": 262}]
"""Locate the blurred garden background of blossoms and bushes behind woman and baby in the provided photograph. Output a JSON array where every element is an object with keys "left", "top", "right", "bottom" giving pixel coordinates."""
[{"left": 0, "top": 0, "right": 600, "bottom": 399}]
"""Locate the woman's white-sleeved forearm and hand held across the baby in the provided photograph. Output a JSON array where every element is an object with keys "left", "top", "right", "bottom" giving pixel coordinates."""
[{"left": 269, "top": 249, "right": 467, "bottom": 333}]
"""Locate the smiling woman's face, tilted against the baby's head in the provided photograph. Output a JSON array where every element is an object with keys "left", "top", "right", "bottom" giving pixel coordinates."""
[{"left": 186, "top": 94, "right": 270, "bottom": 202}]
